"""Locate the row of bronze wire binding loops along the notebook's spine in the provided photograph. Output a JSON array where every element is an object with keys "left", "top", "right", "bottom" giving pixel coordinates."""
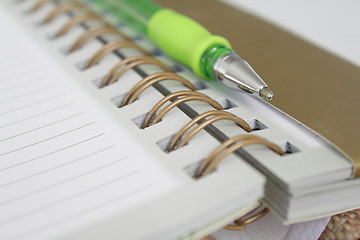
[{"left": 19, "top": 0, "right": 285, "bottom": 230}]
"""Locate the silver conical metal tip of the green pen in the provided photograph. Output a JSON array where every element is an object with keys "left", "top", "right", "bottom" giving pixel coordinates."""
[{"left": 213, "top": 53, "right": 274, "bottom": 100}]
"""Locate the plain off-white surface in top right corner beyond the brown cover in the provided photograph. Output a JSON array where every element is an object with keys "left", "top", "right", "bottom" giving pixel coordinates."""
[{"left": 222, "top": 0, "right": 360, "bottom": 66}]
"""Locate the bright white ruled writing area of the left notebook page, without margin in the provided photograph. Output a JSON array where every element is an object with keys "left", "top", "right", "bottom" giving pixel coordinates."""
[{"left": 0, "top": 9, "right": 175, "bottom": 239}]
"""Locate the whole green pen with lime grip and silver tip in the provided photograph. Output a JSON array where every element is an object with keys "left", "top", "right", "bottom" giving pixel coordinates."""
[{"left": 95, "top": 0, "right": 274, "bottom": 100}]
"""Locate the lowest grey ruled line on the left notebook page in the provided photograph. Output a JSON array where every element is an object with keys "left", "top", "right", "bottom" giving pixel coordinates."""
[{"left": 4, "top": 184, "right": 153, "bottom": 240}]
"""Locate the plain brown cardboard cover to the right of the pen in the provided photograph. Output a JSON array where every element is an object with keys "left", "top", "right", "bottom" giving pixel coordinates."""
[{"left": 156, "top": 0, "right": 360, "bottom": 175}]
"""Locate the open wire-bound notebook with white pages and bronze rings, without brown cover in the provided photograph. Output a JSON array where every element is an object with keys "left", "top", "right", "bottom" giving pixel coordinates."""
[{"left": 0, "top": 0, "right": 360, "bottom": 239}]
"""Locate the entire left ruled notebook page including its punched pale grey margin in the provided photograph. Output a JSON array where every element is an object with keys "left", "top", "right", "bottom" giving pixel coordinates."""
[{"left": 0, "top": 1, "right": 265, "bottom": 240}]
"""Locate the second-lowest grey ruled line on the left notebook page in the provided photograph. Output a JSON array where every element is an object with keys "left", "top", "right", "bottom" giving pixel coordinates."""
[{"left": 0, "top": 169, "right": 140, "bottom": 226}]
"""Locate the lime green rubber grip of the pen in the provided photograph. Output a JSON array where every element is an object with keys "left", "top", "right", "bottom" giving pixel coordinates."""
[{"left": 147, "top": 9, "right": 231, "bottom": 78}]
